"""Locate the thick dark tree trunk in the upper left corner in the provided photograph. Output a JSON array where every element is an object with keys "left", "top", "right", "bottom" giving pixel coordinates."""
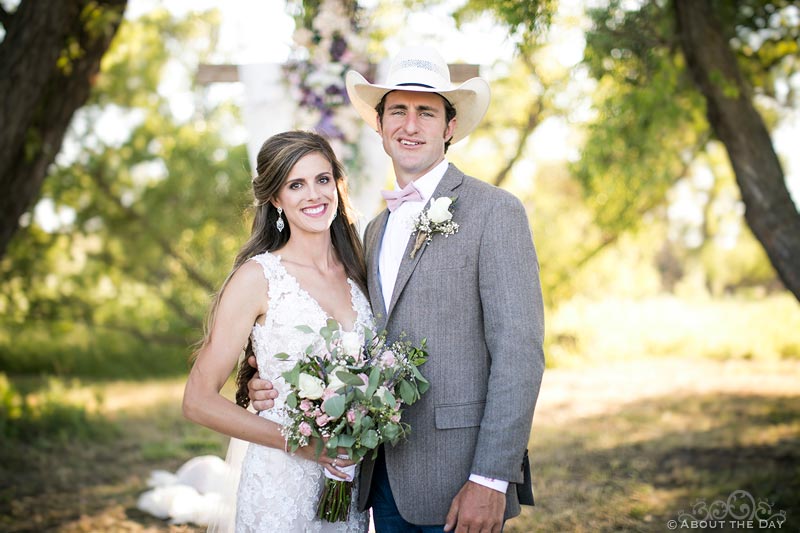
[{"left": 0, "top": 0, "right": 127, "bottom": 257}]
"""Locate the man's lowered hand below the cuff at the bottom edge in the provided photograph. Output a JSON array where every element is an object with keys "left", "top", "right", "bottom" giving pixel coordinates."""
[{"left": 444, "top": 481, "right": 506, "bottom": 533}]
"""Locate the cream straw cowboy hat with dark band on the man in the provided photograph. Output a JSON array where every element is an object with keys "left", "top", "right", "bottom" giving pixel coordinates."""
[{"left": 345, "top": 46, "right": 490, "bottom": 143}]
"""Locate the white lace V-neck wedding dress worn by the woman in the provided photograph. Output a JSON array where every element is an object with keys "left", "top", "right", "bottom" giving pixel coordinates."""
[{"left": 231, "top": 253, "right": 372, "bottom": 533}]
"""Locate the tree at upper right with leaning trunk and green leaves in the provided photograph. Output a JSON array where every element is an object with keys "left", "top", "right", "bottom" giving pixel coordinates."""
[{"left": 576, "top": 0, "right": 800, "bottom": 298}]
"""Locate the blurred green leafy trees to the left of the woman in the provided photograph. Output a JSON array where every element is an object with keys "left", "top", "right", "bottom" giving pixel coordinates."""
[{"left": 0, "top": 9, "right": 252, "bottom": 377}]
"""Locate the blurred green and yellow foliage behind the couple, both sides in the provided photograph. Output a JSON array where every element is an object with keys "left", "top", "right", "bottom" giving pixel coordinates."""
[{"left": 0, "top": 0, "right": 800, "bottom": 378}]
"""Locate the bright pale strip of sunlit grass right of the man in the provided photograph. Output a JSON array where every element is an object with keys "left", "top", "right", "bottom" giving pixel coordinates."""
[{"left": 545, "top": 294, "right": 800, "bottom": 367}]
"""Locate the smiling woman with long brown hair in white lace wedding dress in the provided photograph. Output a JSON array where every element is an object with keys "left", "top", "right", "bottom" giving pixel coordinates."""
[{"left": 183, "top": 131, "right": 372, "bottom": 533}]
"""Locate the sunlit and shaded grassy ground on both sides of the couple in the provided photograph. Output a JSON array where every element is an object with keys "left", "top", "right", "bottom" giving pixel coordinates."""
[{"left": 0, "top": 295, "right": 800, "bottom": 533}]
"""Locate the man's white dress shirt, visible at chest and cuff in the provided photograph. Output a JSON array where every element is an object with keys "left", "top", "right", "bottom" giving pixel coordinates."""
[{"left": 378, "top": 159, "right": 508, "bottom": 494}]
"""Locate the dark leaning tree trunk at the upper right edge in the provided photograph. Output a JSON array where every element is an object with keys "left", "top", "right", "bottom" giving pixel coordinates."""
[{"left": 674, "top": 0, "right": 800, "bottom": 300}]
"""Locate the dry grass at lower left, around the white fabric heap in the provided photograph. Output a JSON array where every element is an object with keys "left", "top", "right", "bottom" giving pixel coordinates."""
[{"left": 0, "top": 379, "right": 227, "bottom": 533}]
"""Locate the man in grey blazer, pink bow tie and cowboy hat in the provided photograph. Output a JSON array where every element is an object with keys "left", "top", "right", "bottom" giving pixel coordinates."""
[{"left": 251, "top": 47, "right": 544, "bottom": 533}]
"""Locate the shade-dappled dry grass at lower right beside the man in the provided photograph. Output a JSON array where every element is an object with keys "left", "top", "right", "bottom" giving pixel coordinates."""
[{"left": 506, "top": 394, "right": 800, "bottom": 532}]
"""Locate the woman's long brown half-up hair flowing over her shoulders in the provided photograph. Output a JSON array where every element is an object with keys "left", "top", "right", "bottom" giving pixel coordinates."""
[{"left": 192, "top": 131, "right": 367, "bottom": 407}]
